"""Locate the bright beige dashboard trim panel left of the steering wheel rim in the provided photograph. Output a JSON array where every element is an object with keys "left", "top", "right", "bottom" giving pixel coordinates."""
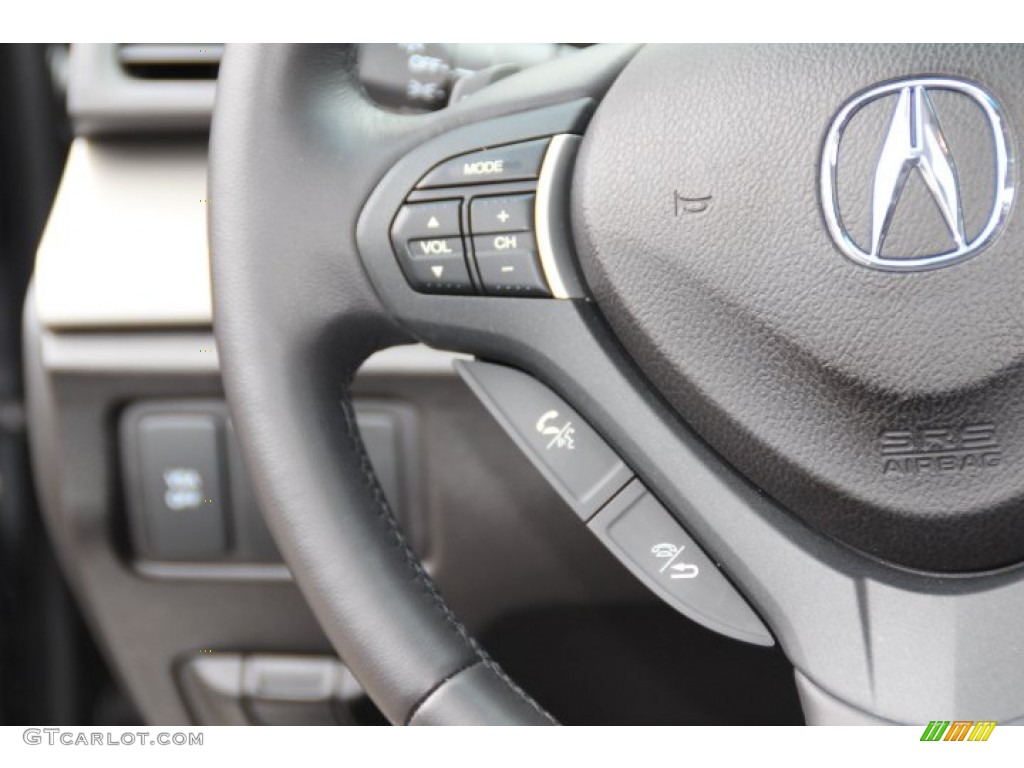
[{"left": 35, "top": 138, "right": 212, "bottom": 330}]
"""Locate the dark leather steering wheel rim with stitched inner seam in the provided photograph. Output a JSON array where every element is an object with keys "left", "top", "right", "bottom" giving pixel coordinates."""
[{"left": 210, "top": 45, "right": 632, "bottom": 724}]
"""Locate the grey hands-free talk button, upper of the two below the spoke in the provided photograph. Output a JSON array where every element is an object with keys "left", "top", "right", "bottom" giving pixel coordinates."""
[{"left": 455, "top": 360, "right": 633, "bottom": 520}]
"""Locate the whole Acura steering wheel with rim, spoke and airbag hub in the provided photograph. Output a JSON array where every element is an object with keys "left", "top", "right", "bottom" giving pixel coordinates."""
[{"left": 210, "top": 45, "right": 1024, "bottom": 724}]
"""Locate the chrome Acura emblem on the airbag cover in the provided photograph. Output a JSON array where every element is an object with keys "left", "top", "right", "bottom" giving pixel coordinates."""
[{"left": 821, "top": 78, "right": 1014, "bottom": 271}]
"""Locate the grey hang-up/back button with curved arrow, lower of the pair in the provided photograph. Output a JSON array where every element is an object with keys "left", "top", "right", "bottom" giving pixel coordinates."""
[{"left": 589, "top": 480, "right": 774, "bottom": 645}]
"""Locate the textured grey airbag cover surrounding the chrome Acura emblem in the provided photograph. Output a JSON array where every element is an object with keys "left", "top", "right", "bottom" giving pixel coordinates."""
[{"left": 572, "top": 41, "right": 1024, "bottom": 571}]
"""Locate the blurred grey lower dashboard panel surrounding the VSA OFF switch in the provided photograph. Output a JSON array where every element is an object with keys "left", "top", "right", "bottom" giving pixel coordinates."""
[{"left": 26, "top": 290, "right": 651, "bottom": 725}]
